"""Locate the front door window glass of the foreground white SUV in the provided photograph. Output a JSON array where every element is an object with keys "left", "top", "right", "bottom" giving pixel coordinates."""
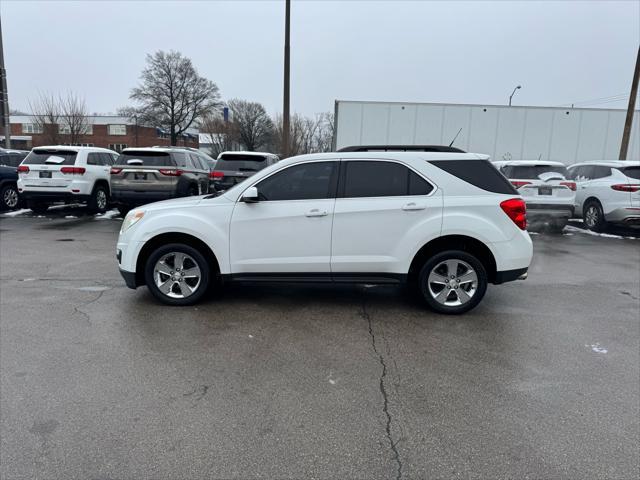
[{"left": 256, "top": 162, "right": 337, "bottom": 201}]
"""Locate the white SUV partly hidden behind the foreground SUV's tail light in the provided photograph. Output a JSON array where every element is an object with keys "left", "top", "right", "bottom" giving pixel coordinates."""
[{"left": 494, "top": 160, "right": 576, "bottom": 231}]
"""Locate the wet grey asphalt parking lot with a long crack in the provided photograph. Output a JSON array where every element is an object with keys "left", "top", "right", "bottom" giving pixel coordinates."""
[{"left": 0, "top": 208, "right": 640, "bottom": 479}]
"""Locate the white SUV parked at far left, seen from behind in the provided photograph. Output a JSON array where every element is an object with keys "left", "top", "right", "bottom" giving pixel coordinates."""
[{"left": 18, "top": 145, "right": 118, "bottom": 213}]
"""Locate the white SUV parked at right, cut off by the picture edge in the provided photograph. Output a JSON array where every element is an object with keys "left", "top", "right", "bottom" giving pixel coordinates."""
[{"left": 569, "top": 160, "right": 640, "bottom": 232}]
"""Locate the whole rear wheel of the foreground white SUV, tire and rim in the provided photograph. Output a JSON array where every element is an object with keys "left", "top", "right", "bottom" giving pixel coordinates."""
[{"left": 418, "top": 250, "right": 488, "bottom": 314}]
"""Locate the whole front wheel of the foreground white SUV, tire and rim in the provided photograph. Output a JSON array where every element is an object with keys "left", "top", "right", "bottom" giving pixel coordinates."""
[{"left": 145, "top": 243, "right": 211, "bottom": 305}]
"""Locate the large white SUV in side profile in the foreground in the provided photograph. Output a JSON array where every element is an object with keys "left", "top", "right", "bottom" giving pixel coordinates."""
[{"left": 116, "top": 152, "right": 532, "bottom": 313}]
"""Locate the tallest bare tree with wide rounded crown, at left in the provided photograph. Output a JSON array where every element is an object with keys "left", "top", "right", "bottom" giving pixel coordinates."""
[{"left": 130, "top": 50, "right": 220, "bottom": 145}]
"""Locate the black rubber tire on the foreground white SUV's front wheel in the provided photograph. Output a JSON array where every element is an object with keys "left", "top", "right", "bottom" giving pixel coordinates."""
[{"left": 144, "top": 243, "right": 211, "bottom": 305}]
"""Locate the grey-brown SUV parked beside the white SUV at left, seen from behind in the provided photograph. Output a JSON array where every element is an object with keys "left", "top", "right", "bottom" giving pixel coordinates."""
[{"left": 111, "top": 147, "right": 209, "bottom": 214}]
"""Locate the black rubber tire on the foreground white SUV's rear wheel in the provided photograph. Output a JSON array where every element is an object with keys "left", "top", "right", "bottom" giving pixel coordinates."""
[{"left": 418, "top": 250, "right": 488, "bottom": 315}]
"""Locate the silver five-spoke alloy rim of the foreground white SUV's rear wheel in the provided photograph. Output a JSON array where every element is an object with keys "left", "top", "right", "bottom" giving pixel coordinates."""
[{"left": 427, "top": 259, "right": 478, "bottom": 307}]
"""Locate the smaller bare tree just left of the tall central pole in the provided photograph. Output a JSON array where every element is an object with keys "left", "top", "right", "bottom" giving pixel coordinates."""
[{"left": 229, "top": 98, "right": 273, "bottom": 151}]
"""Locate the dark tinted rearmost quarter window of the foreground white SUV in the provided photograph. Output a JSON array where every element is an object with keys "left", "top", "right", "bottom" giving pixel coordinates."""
[{"left": 429, "top": 160, "right": 518, "bottom": 195}]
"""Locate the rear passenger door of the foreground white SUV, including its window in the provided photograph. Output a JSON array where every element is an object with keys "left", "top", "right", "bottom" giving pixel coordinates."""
[{"left": 331, "top": 160, "right": 442, "bottom": 274}]
